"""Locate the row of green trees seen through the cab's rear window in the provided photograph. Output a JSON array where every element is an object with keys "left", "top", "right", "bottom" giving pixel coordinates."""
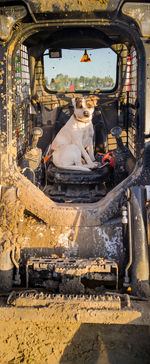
[{"left": 47, "top": 73, "right": 115, "bottom": 91}]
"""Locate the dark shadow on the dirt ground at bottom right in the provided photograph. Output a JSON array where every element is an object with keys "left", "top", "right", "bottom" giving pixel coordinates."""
[{"left": 59, "top": 324, "right": 150, "bottom": 364}]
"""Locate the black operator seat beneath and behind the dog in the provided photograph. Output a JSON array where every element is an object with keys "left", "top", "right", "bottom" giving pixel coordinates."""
[{"left": 44, "top": 105, "right": 112, "bottom": 202}]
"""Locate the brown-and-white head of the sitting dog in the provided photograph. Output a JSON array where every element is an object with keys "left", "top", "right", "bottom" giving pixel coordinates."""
[{"left": 72, "top": 97, "right": 95, "bottom": 122}]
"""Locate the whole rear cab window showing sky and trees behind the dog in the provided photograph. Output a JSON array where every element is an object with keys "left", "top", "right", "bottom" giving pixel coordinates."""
[{"left": 44, "top": 48, "right": 117, "bottom": 91}]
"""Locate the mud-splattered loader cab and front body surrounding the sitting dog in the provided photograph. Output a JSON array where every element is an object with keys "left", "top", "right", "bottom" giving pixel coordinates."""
[{"left": 0, "top": 0, "right": 150, "bottom": 300}]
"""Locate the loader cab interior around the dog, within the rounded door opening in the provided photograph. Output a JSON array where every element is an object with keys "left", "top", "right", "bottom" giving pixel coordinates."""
[{"left": 13, "top": 24, "right": 141, "bottom": 203}]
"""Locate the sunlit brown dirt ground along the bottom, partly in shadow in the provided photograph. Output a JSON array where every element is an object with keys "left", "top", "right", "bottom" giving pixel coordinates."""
[{"left": 0, "top": 321, "right": 150, "bottom": 364}]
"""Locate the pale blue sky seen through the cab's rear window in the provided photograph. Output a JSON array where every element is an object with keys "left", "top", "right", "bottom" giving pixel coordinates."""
[{"left": 44, "top": 48, "right": 117, "bottom": 82}]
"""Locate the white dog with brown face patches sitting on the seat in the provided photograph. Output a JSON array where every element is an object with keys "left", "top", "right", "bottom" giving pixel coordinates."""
[{"left": 51, "top": 97, "right": 97, "bottom": 172}]
